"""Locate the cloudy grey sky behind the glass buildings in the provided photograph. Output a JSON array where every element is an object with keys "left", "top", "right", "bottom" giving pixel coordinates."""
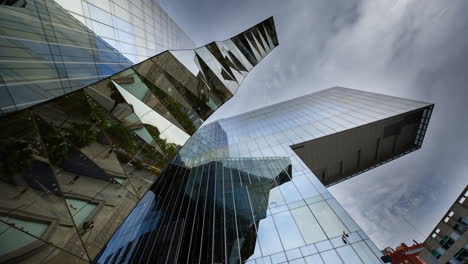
[{"left": 158, "top": 0, "right": 468, "bottom": 248}]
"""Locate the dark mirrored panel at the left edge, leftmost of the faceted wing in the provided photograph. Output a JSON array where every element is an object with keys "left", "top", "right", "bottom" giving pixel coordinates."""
[{"left": 0, "top": 111, "right": 87, "bottom": 259}]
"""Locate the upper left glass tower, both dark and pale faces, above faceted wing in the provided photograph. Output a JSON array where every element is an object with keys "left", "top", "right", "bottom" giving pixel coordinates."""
[{"left": 0, "top": 0, "right": 194, "bottom": 114}]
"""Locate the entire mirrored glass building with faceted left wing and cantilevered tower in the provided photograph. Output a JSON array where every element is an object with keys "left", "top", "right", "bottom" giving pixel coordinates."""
[{"left": 0, "top": 0, "right": 433, "bottom": 264}]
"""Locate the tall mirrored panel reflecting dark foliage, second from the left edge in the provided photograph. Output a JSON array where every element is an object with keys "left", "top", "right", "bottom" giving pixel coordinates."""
[{"left": 29, "top": 92, "right": 137, "bottom": 258}]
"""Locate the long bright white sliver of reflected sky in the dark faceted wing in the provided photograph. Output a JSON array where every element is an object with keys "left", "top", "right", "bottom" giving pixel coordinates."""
[{"left": 112, "top": 81, "right": 190, "bottom": 146}]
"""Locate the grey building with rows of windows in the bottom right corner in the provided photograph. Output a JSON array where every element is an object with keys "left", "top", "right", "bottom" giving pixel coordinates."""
[{"left": 419, "top": 186, "right": 468, "bottom": 264}]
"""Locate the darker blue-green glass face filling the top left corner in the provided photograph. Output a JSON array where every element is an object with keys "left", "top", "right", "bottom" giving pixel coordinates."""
[{"left": 0, "top": 0, "right": 133, "bottom": 114}]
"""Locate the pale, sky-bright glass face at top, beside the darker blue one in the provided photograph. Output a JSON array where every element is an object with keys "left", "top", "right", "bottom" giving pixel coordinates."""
[{"left": 56, "top": 0, "right": 195, "bottom": 63}]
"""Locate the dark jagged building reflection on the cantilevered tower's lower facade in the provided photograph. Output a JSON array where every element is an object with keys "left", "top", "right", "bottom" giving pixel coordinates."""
[{"left": 97, "top": 158, "right": 291, "bottom": 263}]
